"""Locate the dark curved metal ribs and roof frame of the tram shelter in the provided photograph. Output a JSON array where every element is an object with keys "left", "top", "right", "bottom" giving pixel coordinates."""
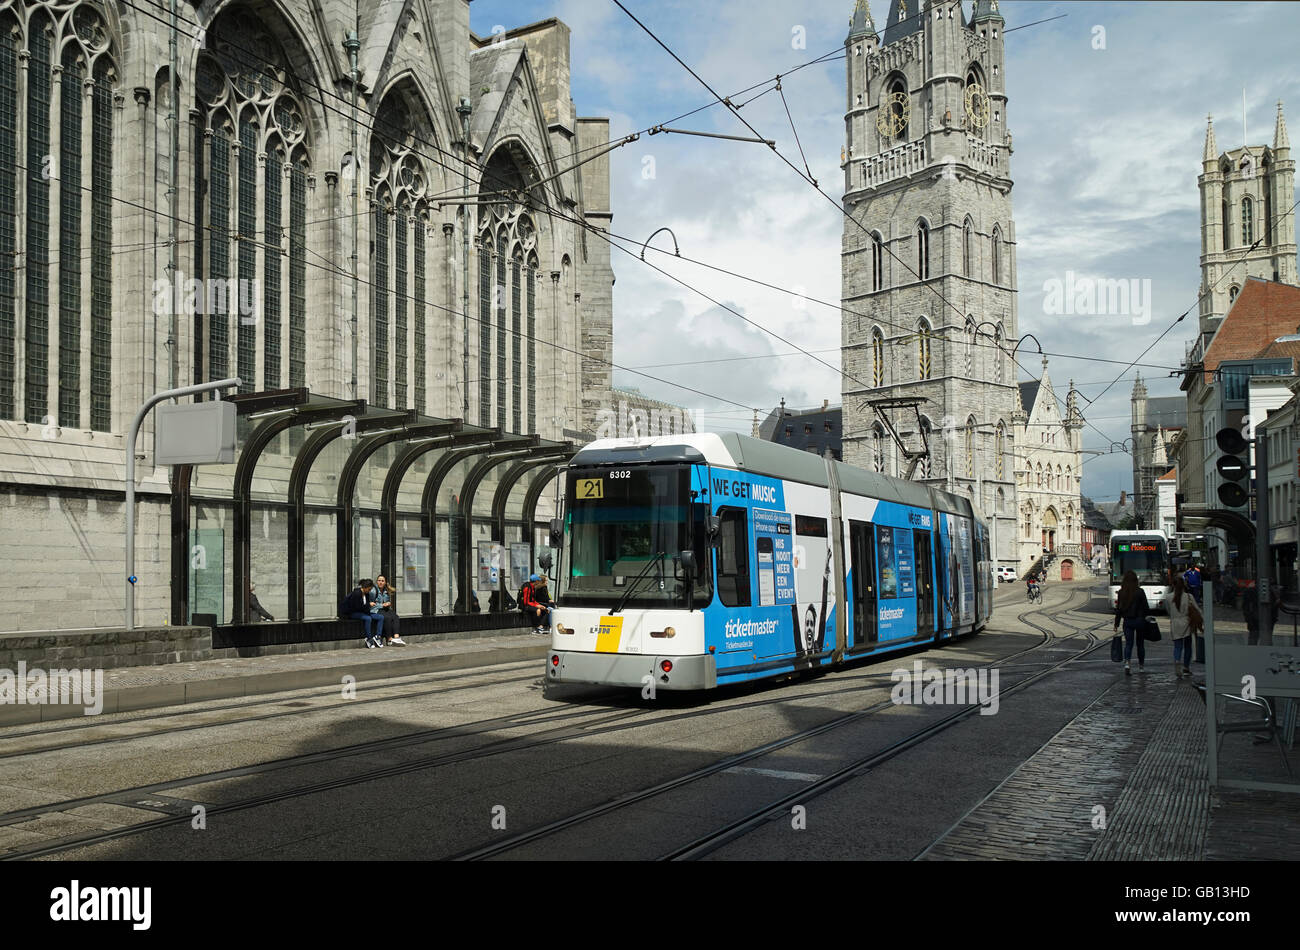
[{"left": 170, "top": 389, "right": 575, "bottom": 645}]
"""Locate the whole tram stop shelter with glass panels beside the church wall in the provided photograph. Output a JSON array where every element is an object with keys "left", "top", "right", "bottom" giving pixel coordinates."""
[{"left": 170, "top": 389, "right": 576, "bottom": 648}]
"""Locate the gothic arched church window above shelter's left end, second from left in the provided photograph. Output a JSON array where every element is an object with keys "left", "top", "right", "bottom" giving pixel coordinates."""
[{"left": 194, "top": 10, "right": 309, "bottom": 391}]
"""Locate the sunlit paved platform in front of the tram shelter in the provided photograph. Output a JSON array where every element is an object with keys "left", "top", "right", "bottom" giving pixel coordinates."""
[{"left": 0, "top": 632, "right": 551, "bottom": 726}]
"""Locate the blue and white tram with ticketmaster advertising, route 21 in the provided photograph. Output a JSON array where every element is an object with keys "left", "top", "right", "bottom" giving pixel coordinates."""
[{"left": 547, "top": 434, "right": 992, "bottom": 690}]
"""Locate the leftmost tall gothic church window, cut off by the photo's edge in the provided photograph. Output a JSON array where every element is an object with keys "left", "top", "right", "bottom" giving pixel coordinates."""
[{"left": 0, "top": 3, "right": 118, "bottom": 431}]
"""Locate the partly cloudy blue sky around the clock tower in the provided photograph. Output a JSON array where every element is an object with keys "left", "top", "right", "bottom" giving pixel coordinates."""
[{"left": 469, "top": 0, "right": 1300, "bottom": 500}]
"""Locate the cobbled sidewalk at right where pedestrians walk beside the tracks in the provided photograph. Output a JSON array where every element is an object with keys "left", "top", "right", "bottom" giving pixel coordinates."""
[{"left": 922, "top": 612, "right": 1300, "bottom": 860}]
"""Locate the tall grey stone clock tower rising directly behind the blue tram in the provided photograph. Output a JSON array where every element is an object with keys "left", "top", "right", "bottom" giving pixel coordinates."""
[{"left": 841, "top": 0, "right": 1019, "bottom": 560}]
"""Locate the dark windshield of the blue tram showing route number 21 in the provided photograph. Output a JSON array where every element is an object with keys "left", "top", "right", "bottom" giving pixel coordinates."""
[{"left": 560, "top": 465, "right": 711, "bottom": 610}]
